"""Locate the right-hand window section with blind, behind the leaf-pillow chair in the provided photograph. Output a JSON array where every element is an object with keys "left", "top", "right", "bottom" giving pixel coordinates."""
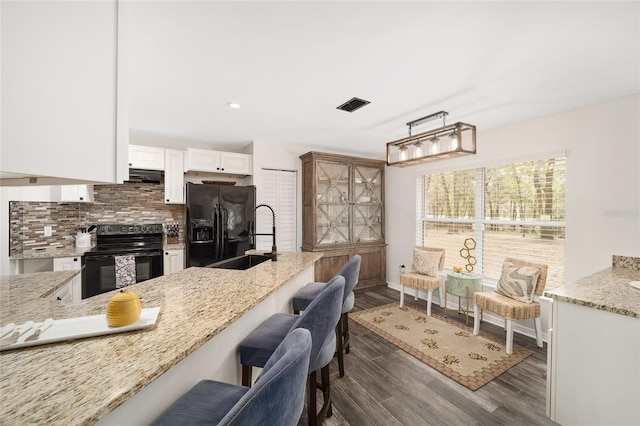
[{"left": 483, "top": 158, "right": 566, "bottom": 284}]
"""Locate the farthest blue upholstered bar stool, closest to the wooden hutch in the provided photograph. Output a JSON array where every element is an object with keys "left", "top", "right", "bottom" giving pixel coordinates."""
[{"left": 292, "top": 254, "right": 361, "bottom": 377}]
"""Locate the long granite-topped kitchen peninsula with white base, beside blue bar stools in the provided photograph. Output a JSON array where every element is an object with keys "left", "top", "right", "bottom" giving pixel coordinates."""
[{"left": 0, "top": 252, "right": 322, "bottom": 425}]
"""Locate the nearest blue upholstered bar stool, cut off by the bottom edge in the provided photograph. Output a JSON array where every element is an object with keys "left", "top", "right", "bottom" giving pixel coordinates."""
[{"left": 153, "top": 328, "right": 311, "bottom": 426}]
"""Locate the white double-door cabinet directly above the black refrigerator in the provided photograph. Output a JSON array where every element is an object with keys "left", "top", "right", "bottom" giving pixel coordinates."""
[{"left": 185, "top": 148, "right": 251, "bottom": 175}]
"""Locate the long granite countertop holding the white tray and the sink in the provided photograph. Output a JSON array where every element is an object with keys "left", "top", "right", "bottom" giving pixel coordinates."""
[{"left": 0, "top": 252, "right": 322, "bottom": 425}]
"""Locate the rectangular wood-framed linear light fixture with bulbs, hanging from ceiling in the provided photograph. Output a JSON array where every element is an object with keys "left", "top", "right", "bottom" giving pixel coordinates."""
[{"left": 387, "top": 111, "right": 476, "bottom": 167}]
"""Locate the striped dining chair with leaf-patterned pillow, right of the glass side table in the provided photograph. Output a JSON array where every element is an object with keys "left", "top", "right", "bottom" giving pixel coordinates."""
[{"left": 473, "top": 257, "right": 548, "bottom": 354}]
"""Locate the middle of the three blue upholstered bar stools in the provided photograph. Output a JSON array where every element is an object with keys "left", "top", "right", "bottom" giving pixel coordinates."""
[{"left": 240, "top": 275, "right": 344, "bottom": 426}]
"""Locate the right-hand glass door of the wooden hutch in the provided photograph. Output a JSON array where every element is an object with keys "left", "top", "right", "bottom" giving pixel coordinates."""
[{"left": 353, "top": 166, "right": 383, "bottom": 242}]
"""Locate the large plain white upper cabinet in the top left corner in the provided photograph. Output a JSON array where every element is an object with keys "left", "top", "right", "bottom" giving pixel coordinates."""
[{"left": 0, "top": 0, "right": 128, "bottom": 185}]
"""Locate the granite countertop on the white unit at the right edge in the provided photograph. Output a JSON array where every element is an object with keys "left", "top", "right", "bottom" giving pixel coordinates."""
[{"left": 544, "top": 267, "right": 640, "bottom": 318}]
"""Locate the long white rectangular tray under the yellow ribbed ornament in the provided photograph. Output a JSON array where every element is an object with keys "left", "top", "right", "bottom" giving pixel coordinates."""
[{"left": 0, "top": 308, "right": 160, "bottom": 351}]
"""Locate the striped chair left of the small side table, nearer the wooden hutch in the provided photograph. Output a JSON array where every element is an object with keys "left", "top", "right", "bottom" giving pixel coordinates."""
[{"left": 400, "top": 246, "right": 444, "bottom": 316}]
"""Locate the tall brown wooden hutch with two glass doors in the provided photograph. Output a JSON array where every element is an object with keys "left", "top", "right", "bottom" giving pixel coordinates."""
[{"left": 300, "top": 152, "right": 386, "bottom": 289}]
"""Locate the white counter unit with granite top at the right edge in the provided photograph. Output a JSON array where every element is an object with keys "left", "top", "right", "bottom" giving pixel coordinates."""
[{"left": 545, "top": 256, "right": 640, "bottom": 425}]
